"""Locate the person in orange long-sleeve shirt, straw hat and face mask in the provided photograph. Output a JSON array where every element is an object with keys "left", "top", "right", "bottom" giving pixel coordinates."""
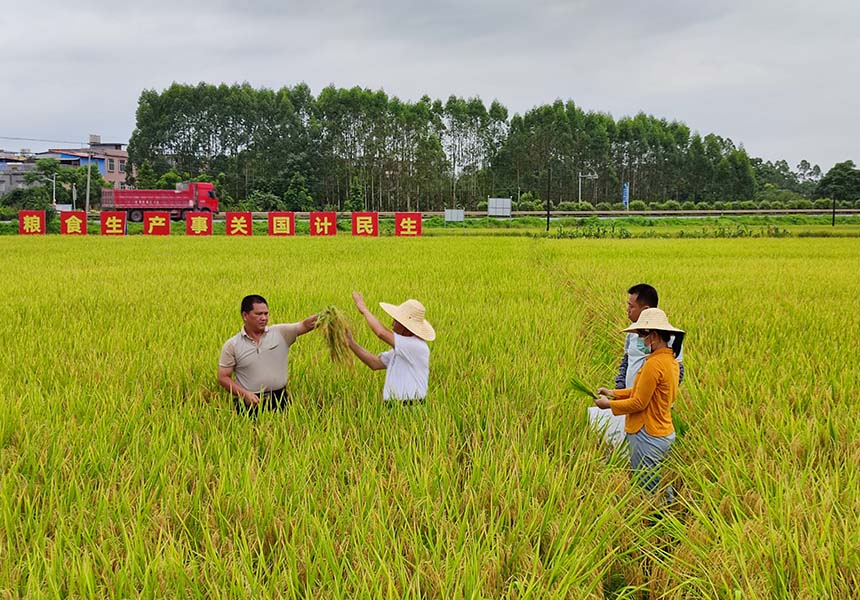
[{"left": 594, "top": 308, "right": 684, "bottom": 501}]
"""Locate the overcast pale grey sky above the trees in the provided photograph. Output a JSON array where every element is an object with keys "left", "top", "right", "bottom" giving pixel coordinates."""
[{"left": 0, "top": 0, "right": 860, "bottom": 171}]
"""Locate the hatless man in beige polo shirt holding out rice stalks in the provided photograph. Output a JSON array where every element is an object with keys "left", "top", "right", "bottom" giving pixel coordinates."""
[{"left": 218, "top": 294, "right": 317, "bottom": 414}]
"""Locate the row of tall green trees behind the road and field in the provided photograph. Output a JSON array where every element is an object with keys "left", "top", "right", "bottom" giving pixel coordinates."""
[{"left": 129, "top": 83, "right": 840, "bottom": 210}]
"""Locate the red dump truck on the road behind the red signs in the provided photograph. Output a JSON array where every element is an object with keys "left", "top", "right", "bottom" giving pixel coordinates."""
[{"left": 102, "top": 182, "right": 218, "bottom": 223}]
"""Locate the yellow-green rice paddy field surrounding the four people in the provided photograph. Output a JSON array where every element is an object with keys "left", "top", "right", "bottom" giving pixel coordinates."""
[{"left": 0, "top": 236, "right": 860, "bottom": 599}]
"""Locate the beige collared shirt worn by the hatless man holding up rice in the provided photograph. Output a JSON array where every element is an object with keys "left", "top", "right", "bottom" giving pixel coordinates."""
[{"left": 218, "top": 323, "right": 299, "bottom": 394}]
